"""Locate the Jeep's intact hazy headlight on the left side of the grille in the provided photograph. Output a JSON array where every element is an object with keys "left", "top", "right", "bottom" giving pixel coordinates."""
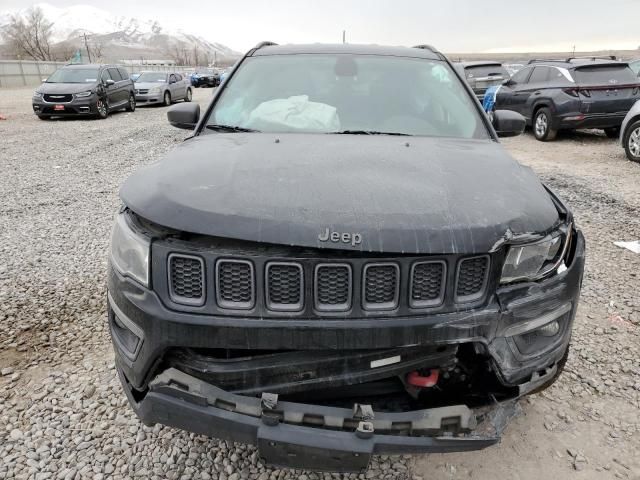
[{"left": 111, "top": 213, "right": 151, "bottom": 287}]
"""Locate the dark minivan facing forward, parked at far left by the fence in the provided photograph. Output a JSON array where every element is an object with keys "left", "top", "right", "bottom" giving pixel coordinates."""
[{"left": 32, "top": 65, "right": 136, "bottom": 120}]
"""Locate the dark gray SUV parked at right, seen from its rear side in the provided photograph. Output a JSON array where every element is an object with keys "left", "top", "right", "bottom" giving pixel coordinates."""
[{"left": 495, "top": 58, "right": 640, "bottom": 141}]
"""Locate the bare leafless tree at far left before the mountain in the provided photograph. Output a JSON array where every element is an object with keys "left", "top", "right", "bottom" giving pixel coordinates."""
[{"left": 2, "top": 7, "right": 53, "bottom": 60}]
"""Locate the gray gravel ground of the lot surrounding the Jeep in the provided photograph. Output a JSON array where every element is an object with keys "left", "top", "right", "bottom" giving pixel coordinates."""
[{"left": 0, "top": 89, "right": 640, "bottom": 480}]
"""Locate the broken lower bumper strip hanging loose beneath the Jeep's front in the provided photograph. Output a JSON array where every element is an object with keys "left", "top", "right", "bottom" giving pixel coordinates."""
[{"left": 121, "top": 369, "right": 518, "bottom": 472}]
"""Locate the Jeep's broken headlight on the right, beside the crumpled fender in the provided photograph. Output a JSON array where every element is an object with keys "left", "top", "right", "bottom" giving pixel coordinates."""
[{"left": 500, "top": 225, "right": 572, "bottom": 283}]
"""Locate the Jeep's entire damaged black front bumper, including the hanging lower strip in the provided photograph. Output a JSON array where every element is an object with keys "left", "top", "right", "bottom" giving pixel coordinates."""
[{"left": 108, "top": 232, "right": 584, "bottom": 471}]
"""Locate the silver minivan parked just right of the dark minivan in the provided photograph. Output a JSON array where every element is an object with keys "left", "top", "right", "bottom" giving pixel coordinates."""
[{"left": 135, "top": 72, "right": 192, "bottom": 106}]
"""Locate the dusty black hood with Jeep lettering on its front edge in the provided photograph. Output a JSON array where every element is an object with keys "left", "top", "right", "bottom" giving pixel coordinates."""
[{"left": 120, "top": 133, "right": 558, "bottom": 254}]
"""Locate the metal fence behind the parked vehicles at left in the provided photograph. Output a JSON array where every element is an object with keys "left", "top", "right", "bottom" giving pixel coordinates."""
[{"left": 0, "top": 60, "right": 194, "bottom": 88}]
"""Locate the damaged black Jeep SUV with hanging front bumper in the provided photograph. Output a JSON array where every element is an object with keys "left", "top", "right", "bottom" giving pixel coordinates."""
[{"left": 108, "top": 43, "right": 585, "bottom": 471}]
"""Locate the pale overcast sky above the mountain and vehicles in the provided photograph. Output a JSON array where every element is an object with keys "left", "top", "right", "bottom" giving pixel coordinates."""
[{"left": 5, "top": 0, "right": 640, "bottom": 53}]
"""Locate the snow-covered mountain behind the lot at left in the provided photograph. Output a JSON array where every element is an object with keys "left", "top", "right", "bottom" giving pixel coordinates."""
[{"left": 0, "top": 3, "right": 240, "bottom": 63}]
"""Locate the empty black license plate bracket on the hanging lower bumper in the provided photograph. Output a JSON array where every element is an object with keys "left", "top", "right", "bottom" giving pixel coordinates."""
[{"left": 258, "top": 424, "right": 373, "bottom": 473}]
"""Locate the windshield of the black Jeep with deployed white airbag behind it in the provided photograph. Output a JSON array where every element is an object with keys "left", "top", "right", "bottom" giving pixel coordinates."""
[{"left": 207, "top": 54, "right": 488, "bottom": 138}]
